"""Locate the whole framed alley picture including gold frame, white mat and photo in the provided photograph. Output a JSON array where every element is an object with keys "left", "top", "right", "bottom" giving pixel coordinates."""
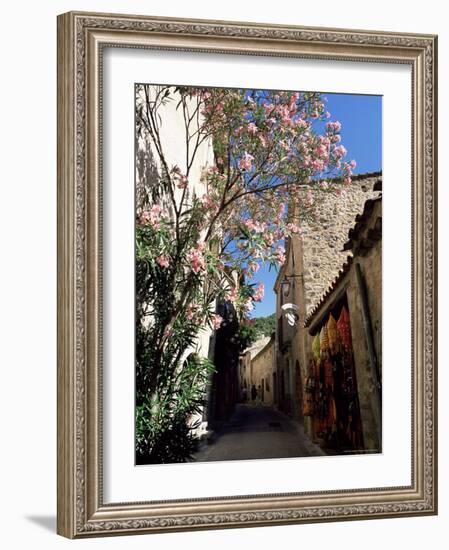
[{"left": 58, "top": 12, "right": 437, "bottom": 538}]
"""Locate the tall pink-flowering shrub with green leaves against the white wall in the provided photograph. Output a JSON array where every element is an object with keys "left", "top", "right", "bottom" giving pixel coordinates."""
[{"left": 136, "top": 85, "right": 355, "bottom": 462}]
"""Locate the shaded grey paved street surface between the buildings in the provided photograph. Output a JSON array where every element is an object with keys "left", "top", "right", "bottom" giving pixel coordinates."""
[{"left": 192, "top": 404, "right": 325, "bottom": 462}]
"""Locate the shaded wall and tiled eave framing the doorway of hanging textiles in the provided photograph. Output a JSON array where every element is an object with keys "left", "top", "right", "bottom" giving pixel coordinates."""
[{"left": 302, "top": 196, "right": 382, "bottom": 452}]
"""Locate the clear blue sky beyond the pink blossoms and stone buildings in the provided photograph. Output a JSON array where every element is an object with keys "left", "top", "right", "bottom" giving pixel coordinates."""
[{"left": 251, "top": 93, "right": 382, "bottom": 317}]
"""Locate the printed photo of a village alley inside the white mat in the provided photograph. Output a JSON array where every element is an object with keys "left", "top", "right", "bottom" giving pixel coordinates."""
[{"left": 135, "top": 83, "right": 383, "bottom": 464}]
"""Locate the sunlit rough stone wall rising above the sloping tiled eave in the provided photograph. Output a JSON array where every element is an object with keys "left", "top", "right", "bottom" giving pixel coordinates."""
[{"left": 302, "top": 173, "right": 382, "bottom": 315}]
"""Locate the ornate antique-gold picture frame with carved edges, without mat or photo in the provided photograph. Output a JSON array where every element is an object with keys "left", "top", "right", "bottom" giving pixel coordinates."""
[{"left": 57, "top": 12, "right": 437, "bottom": 538}]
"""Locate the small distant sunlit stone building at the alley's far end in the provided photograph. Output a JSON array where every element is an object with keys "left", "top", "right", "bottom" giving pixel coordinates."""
[{"left": 251, "top": 333, "right": 276, "bottom": 405}]
